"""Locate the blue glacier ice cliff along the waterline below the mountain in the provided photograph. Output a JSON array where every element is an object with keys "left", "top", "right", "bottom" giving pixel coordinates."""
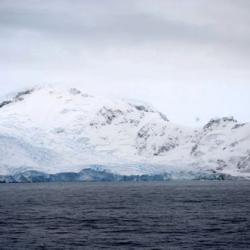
[{"left": 0, "top": 168, "right": 239, "bottom": 183}]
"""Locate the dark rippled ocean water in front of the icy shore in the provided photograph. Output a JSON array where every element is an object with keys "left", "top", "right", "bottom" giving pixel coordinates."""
[{"left": 0, "top": 181, "right": 250, "bottom": 250}]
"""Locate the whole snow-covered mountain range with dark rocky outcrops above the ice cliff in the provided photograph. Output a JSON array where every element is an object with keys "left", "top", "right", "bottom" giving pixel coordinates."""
[{"left": 0, "top": 87, "right": 250, "bottom": 180}]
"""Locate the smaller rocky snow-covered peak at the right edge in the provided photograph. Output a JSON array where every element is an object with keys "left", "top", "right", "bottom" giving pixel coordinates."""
[{"left": 191, "top": 117, "right": 250, "bottom": 175}]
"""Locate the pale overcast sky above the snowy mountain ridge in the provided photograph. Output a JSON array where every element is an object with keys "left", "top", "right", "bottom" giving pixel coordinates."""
[{"left": 0, "top": 0, "right": 250, "bottom": 126}]
